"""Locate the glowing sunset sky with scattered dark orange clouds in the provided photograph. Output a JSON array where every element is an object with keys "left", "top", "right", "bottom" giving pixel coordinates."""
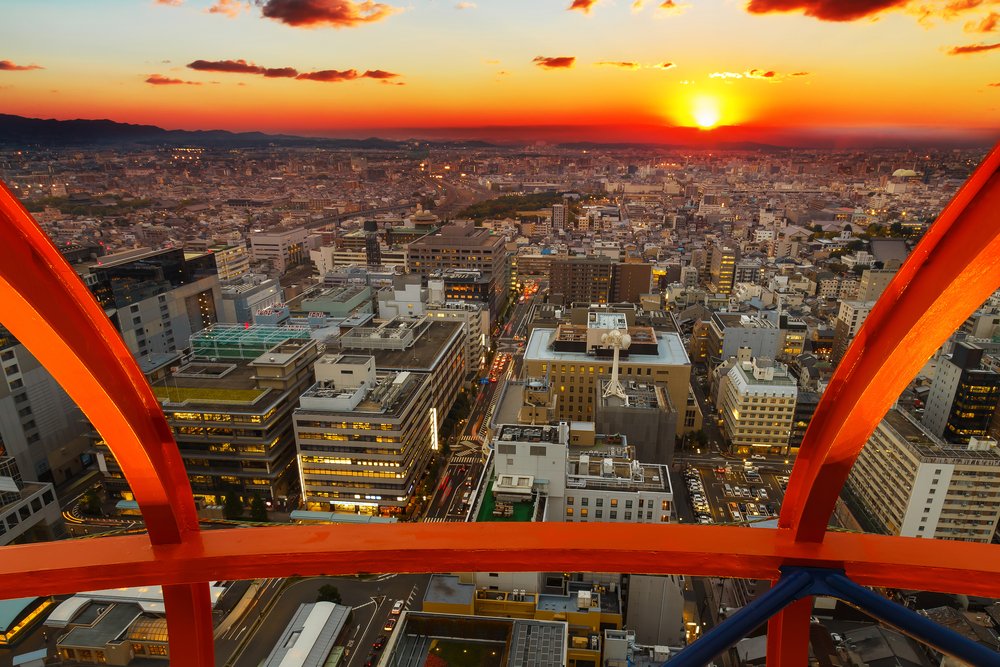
[{"left": 0, "top": 0, "right": 1000, "bottom": 143}]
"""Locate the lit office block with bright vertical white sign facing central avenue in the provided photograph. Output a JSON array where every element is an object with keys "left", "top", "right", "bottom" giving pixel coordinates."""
[{"left": 294, "top": 354, "right": 444, "bottom": 515}]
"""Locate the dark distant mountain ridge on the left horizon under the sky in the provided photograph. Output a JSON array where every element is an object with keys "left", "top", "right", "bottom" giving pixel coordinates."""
[{"left": 0, "top": 114, "right": 408, "bottom": 150}]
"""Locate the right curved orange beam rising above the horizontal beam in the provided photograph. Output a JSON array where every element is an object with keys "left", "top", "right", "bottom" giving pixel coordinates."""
[{"left": 778, "top": 144, "right": 1000, "bottom": 542}]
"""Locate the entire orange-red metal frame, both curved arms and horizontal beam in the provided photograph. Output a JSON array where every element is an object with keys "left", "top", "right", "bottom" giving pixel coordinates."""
[{"left": 0, "top": 146, "right": 1000, "bottom": 667}]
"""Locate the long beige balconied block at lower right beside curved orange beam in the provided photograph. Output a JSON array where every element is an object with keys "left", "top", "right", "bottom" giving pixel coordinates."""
[{"left": 847, "top": 408, "right": 1000, "bottom": 542}]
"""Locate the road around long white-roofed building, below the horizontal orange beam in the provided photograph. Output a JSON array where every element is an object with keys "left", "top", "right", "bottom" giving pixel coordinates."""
[{"left": 227, "top": 575, "right": 430, "bottom": 667}]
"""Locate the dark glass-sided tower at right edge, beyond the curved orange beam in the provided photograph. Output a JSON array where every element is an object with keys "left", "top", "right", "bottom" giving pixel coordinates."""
[{"left": 921, "top": 341, "right": 1000, "bottom": 444}]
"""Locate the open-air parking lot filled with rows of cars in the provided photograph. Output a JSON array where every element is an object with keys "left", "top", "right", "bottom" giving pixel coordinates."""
[{"left": 683, "top": 462, "right": 788, "bottom": 524}]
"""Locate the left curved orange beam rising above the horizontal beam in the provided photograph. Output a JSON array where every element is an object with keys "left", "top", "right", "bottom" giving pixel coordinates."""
[{"left": 0, "top": 183, "right": 198, "bottom": 544}]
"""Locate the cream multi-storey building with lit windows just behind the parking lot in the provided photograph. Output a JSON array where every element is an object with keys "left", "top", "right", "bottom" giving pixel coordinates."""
[{"left": 719, "top": 353, "right": 798, "bottom": 454}]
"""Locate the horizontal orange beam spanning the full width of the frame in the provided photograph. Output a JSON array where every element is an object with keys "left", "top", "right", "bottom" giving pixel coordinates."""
[{"left": 0, "top": 523, "right": 1000, "bottom": 597}]
